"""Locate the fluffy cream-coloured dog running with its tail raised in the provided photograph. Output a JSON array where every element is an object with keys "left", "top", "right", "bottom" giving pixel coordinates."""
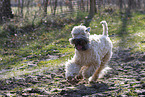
[{"left": 65, "top": 21, "right": 113, "bottom": 82}]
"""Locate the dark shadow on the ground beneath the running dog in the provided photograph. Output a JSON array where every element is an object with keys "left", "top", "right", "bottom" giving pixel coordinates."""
[{"left": 60, "top": 82, "right": 109, "bottom": 97}]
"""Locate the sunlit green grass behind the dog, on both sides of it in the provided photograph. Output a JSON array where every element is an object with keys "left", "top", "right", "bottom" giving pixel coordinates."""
[{"left": 0, "top": 8, "right": 145, "bottom": 78}]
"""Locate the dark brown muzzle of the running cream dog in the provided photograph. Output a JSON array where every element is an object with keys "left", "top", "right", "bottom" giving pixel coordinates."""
[{"left": 71, "top": 38, "right": 89, "bottom": 51}]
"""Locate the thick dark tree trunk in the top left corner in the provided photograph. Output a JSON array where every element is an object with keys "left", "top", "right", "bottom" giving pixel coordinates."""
[{"left": 0, "top": 0, "right": 13, "bottom": 22}]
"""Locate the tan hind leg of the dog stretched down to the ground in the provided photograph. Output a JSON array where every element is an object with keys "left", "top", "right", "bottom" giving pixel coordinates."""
[{"left": 89, "top": 52, "right": 111, "bottom": 82}]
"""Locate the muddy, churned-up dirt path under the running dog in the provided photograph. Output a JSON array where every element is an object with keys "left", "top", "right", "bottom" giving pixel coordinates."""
[{"left": 0, "top": 50, "right": 145, "bottom": 97}]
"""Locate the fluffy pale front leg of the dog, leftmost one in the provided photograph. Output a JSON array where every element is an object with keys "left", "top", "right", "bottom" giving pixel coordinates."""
[{"left": 65, "top": 60, "right": 81, "bottom": 80}]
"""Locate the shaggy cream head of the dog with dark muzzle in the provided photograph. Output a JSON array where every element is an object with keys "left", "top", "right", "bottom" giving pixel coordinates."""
[{"left": 69, "top": 25, "right": 90, "bottom": 51}]
